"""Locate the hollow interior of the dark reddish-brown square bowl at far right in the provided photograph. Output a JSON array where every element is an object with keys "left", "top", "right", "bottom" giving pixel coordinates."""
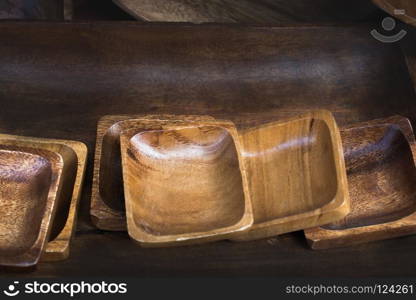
[{"left": 324, "top": 125, "right": 416, "bottom": 230}]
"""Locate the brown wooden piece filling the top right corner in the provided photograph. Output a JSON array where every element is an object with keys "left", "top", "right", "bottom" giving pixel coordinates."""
[{"left": 373, "top": 0, "right": 416, "bottom": 26}]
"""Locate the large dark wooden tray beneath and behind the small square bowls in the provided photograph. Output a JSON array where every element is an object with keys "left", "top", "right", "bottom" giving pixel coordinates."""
[{"left": 0, "top": 23, "right": 416, "bottom": 276}]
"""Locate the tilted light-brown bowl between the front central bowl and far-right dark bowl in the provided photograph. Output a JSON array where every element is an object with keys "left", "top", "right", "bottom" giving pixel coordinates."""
[{"left": 232, "top": 110, "right": 349, "bottom": 241}]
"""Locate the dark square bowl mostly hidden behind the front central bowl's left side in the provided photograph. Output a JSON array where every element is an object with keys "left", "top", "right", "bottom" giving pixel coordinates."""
[{"left": 90, "top": 115, "right": 212, "bottom": 231}]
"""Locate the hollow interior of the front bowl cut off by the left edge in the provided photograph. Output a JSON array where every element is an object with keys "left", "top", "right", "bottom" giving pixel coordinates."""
[{"left": 0, "top": 150, "right": 52, "bottom": 256}]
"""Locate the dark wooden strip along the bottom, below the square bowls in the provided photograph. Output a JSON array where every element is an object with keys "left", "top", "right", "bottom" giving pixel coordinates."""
[{"left": 6, "top": 231, "right": 416, "bottom": 278}]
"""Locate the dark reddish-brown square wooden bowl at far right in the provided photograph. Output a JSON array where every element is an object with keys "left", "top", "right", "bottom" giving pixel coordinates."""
[{"left": 305, "top": 116, "right": 416, "bottom": 249}]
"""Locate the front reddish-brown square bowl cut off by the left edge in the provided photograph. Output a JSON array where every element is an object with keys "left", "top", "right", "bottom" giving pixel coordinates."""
[{"left": 0, "top": 136, "right": 65, "bottom": 267}]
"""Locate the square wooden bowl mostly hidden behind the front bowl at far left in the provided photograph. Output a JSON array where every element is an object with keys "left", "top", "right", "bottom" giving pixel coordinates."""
[{"left": 0, "top": 134, "right": 87, "bottom": 266}]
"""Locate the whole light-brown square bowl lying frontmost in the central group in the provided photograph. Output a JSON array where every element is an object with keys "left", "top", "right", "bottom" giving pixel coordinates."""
[{"left": 120, "top": 120, "right": 253, "bottom": 247}]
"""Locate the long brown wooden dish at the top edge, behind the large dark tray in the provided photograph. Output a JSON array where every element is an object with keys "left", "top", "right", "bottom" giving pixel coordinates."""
[{"left": 113, "top": 0, "right": 376, "bottom": 25}]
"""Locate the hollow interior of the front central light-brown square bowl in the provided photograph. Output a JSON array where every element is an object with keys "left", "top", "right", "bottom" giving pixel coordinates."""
[{"left": 125, "top": 126, "right": 245, "bottom": 236}]
